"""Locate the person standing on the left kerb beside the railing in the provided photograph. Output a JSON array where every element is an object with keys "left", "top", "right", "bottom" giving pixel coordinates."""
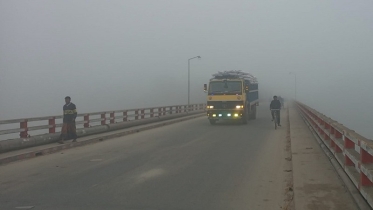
[{"left": 58, "top": 96, "right": 78, "bottom": 144}]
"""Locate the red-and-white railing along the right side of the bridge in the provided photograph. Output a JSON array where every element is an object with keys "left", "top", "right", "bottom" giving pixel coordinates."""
[{"left": 297, "top": 103, "right": 373, "bottom": 207}]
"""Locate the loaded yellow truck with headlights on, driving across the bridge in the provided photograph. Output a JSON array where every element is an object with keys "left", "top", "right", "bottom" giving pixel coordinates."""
[{"left": 204, "top": 70, "right": 259, "bottom": 125}]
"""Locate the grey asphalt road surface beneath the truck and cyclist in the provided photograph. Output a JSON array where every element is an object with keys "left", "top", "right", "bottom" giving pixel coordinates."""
[{"left": 0, "top": 106, "right": 289, "bottom": 210}]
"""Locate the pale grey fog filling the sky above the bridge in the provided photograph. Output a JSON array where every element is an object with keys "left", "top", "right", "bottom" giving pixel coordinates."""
[{"left": 0, "top": 0, "right": 373, "bottom": 138}]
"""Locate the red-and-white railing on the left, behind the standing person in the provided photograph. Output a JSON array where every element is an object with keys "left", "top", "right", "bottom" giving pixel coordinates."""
[{"left": 0, "top": 104, "right": 206, "bottom": 140}]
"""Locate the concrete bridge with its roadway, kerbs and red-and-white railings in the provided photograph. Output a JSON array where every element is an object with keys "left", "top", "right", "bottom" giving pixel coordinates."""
[{"left": 0, "top": 102, "right": 373, "bottom": 210}]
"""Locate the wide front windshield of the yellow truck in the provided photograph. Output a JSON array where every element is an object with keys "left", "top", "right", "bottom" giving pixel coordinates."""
[{"left": 209, "top": 81, "right": 242, "bottom": 95}]
